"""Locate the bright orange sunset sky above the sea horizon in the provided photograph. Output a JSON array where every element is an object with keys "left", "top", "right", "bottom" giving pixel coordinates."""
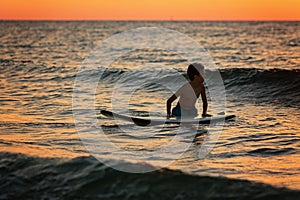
[{"left": 0, "top": 0, "right": 300, "bottom": 20}]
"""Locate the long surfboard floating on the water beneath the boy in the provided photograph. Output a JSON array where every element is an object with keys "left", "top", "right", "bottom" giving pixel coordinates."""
[{"left": 100, "top": 110, "right": 235, "bottom": 126}]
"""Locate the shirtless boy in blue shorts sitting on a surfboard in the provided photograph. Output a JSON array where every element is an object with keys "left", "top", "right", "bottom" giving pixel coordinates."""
[{"left": 167, "top": 63, "right": 211, "bottom": 118}]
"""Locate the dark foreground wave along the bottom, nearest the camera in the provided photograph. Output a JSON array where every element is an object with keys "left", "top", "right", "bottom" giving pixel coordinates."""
[{"left": 0, "top": 152, "right": 300, "bottom": 199}]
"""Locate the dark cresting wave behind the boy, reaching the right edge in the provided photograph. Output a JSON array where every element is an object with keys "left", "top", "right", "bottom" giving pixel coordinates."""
[{"left": 102, "top": 68, "right": 300, "bottom": 108}]
